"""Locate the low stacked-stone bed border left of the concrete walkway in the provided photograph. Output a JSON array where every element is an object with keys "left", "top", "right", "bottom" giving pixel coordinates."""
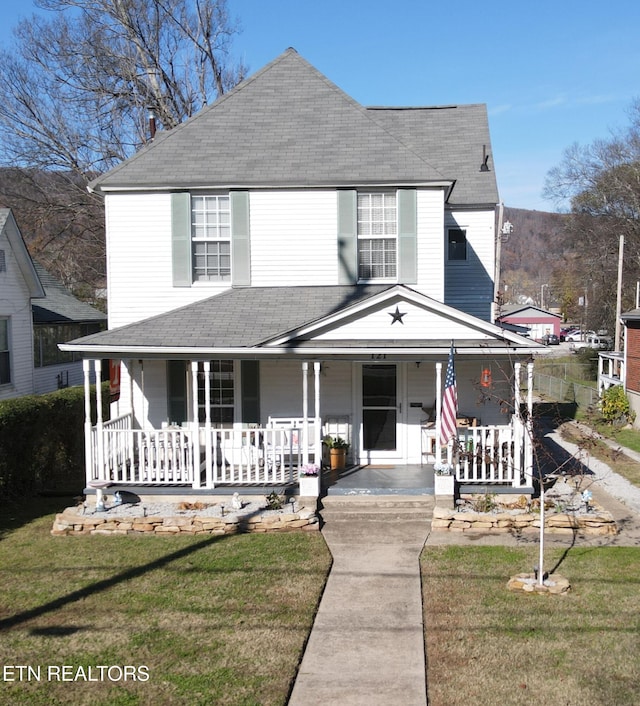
[{"left": 51, "top": 507, "right": 320, "bottom": 537}]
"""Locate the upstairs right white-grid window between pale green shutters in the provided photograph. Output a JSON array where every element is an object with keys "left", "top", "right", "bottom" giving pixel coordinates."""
[{"left": 358, "top": 191, "right": 398, "bottom": 280}]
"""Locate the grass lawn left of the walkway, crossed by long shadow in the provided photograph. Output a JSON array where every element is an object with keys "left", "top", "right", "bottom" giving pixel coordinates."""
[{"left": 0, "top": 500, "right": 331, "bottom": 706}]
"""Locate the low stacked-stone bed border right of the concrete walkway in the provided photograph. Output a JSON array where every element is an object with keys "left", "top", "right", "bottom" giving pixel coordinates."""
[{"left": 431, "top": 506, "right": 618, "bottom": 535}]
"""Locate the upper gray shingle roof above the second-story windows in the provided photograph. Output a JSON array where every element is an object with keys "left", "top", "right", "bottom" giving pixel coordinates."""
[{"left": 92, "top": 49, "right": 498, "bottom": 203}]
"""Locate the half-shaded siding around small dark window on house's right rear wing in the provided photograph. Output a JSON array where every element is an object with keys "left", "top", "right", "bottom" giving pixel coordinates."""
[{"left": 443, "top": 211, "right": 495, "bottom": 321}]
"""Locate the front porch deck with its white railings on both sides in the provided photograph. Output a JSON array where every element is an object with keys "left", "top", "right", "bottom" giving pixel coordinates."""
[{"left": 86, "top": 414, "right": 532, "bottom": 496}]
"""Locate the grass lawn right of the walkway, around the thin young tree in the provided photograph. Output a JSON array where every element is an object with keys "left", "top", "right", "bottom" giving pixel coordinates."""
[{"left": 422, "top": 546, "right": 640, "bottom": 706}]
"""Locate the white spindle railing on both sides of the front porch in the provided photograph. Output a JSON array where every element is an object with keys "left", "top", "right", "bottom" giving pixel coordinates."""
[{"left": 87, "top": 415, "right": 531, "bottom": 489}]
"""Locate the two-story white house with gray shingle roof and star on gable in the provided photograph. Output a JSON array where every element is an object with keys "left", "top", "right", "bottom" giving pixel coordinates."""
[{"left": 62, "top": 49, "right": 539, "bottom": 491}]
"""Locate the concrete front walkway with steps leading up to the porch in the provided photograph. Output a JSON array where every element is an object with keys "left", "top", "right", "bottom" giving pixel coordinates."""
[{"left": 289, "top": 495, "right": 434, "bottom": 706}]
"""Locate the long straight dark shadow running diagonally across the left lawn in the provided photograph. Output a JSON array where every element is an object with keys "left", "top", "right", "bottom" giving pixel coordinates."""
[{"left": 0, "top": 535, "right": 232, "bottom": 632}]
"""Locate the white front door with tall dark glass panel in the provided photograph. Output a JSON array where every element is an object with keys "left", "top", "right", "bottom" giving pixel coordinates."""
[{"left": 362, "top": 365, "right": 400, "bottom": 462}]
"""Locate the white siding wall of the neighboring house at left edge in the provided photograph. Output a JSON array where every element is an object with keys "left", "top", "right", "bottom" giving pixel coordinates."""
[{"left": 0, "top": 228, "right": 34, "bottom": 399}]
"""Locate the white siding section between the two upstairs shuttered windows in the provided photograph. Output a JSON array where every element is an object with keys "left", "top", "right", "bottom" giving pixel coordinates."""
[{"left": 250, "top": 191, "right": 338, "bottom": 287}]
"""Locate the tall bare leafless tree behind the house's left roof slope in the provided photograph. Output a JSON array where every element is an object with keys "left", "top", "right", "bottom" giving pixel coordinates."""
[{"left": 0, "top": 0, "right": 245, "bottom": 296}]
